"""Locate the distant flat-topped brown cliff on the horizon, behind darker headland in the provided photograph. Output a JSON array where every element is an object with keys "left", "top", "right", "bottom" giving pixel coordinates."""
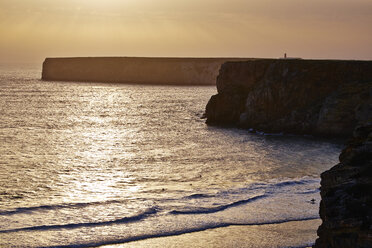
[{"left": 42, "top": 57, "right": 250, "bottom": 85}]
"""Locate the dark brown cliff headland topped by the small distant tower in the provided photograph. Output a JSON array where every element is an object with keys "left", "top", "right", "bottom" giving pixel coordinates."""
[{"left": 206, "top": 59, "right": 372, "bottom": 136}]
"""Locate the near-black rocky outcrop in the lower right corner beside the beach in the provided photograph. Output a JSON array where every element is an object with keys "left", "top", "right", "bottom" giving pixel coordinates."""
[{"left": 314, "top": 123, "right": 372, "bottom": 248}]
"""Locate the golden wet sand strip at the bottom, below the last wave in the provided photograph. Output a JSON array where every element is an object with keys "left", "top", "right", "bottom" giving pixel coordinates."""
[{"left": 102, "top": 219, "right": 321, "bottom": 248}]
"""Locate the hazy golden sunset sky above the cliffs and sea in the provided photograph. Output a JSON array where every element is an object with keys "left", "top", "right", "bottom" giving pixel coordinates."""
[{"left": 0, "top": 0, "right": 372, "bottom": 63}]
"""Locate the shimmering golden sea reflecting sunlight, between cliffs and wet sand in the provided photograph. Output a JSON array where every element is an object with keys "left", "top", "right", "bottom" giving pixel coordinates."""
[{"left": 0, "top": 66, "right": 341, "bottom": 247}]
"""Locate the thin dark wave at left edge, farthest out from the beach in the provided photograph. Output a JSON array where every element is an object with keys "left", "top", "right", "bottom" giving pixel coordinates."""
[{"left": 0, "top": 200, "right": 123, "bottom": 215}]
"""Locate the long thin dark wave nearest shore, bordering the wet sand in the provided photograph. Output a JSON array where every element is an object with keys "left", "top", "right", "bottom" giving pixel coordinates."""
[{"left": 40, "top": 217, "right": 319, "bottom": 248}]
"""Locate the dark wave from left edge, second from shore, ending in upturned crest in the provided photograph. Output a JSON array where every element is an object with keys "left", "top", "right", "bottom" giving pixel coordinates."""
[{"left": 0, "top": 208, "right": 158, "bottom": 233}]
